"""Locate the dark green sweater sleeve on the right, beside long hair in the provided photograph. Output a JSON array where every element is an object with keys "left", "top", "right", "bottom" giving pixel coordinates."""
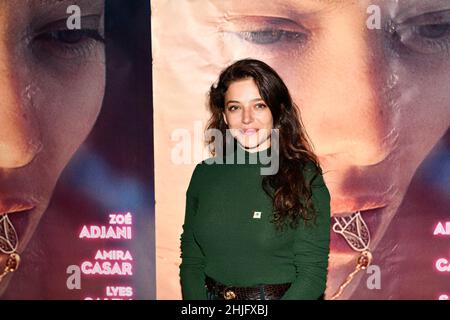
[{"left": 281, "top": 162, "right": 331, "bottom": 300}]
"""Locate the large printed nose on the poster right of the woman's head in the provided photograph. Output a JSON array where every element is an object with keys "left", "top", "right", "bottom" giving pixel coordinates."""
[{"left": 305, "top": 14, "right": 397, "bottom": 165}]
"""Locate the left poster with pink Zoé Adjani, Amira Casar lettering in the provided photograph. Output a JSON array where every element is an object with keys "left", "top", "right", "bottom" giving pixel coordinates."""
[{"left": 0, "top": 0, "right": 156, "bottom": 300}]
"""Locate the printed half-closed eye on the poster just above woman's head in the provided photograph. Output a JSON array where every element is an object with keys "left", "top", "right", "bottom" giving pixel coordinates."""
[{"left": 237, "top": 30, "right": 307, "bottom": 45}]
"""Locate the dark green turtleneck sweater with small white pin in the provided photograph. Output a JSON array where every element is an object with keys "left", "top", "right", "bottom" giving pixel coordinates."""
[{"left": 180, "top": 148, "right": 330, "bottom": 300}]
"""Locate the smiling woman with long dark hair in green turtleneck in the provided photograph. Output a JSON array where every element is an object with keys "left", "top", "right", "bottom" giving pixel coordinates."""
[{"left": 180, "top": 59, "right": 330, "bottom": 300}]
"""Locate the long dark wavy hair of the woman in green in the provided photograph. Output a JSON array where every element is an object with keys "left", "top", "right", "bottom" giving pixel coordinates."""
[{"left": 206, "top": 59, "right": 322, "bottom": 229}]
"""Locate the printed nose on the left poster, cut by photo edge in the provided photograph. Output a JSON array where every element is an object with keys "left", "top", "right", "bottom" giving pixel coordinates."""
[{"left": 0, "top": 47, "right": 42, "bottom": 169}]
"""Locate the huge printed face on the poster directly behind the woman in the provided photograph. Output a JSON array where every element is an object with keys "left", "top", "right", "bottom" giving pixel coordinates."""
[{"left": 155, "top": 0, "right": 450, "bottom": 295}]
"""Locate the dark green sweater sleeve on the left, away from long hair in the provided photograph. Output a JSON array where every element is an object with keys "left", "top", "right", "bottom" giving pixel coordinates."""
[{"left": 180, "top": 165, "right": 207, "bottom": 300}]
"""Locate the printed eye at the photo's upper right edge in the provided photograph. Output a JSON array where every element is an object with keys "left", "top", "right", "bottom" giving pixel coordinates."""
[{"left": 396, "top": 10, "right": 450, "bottom": 54}]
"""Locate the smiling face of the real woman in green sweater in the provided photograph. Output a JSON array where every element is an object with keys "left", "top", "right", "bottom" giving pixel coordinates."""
[{"left": 223, "top": 78, "right": 273, "bottom": 152}]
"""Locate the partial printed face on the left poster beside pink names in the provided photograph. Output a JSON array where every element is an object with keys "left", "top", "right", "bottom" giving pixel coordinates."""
[{"left": 0, "top": 0, "right": 105, "bottom": 291}]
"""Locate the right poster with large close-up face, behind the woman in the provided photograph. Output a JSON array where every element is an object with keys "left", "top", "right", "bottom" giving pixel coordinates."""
[{"left": 151, "top": 0, "right": 450, "bottom": 299}]
